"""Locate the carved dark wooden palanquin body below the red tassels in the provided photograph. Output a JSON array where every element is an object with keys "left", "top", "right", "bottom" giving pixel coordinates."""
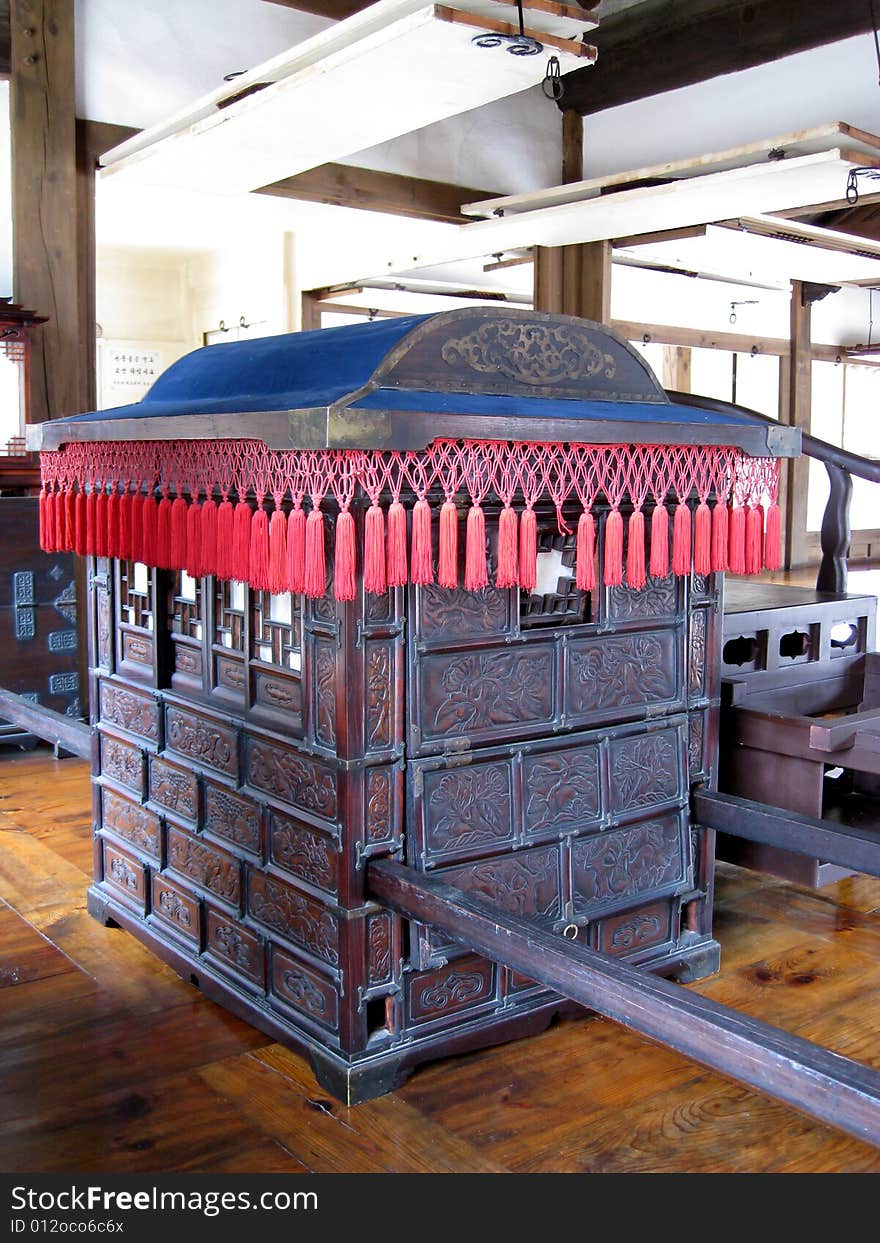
[{"left": 89, "top": 494, "right": 721, "bottom": 1101}]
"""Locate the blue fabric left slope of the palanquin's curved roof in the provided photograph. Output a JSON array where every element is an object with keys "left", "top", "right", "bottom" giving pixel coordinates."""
[{"left": 71, "top": 314, "right": 430, "bottom": 423}]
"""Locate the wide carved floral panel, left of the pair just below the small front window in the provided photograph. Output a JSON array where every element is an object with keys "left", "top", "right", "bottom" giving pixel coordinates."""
[{"left": 419, "top": 644, "right": 556, "bottom": 742}]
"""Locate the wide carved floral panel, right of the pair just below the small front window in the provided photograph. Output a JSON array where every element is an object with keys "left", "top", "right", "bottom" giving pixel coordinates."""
[{"left": 566, "top": 630, "right": 681, "bottom": 717}]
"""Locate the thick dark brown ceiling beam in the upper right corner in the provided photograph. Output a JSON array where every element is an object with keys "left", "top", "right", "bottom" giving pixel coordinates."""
[{"left": 559, "top": 0, "right": 871, "bottom": 116}]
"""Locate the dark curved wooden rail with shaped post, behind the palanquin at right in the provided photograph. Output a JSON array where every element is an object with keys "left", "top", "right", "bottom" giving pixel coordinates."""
[{"left": 669, "top": 393, "right": 880, "bottom": 592}]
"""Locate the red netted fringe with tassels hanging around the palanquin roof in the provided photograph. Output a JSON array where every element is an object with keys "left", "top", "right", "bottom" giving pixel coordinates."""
[{"left": 40, "top": 440, "right": 781, "bottom": 598}]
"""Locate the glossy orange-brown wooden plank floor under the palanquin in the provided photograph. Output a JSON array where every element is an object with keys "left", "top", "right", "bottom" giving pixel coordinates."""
[{"left": 0, "top": 751, "right": 880, "bottom": 1172}]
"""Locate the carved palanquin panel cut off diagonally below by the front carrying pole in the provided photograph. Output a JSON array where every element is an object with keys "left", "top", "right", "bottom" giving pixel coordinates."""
[{"left": 438, "top": 846, "right": 562, "bottom": 921}]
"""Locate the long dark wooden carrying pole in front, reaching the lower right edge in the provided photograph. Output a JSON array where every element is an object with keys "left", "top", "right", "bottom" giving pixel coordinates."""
[{"left": 367, "top": 860, "right": 880, "bottom": 1146}]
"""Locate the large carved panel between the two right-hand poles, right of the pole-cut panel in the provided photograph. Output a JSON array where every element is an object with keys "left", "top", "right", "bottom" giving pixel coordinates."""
[{"left": 572, "top": 813, "right": 687, "bottom": 915}]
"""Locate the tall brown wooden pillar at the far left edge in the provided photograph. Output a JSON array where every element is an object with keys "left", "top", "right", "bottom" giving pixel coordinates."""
[{"left": 10, "top": 0, "right": 82, "bottom": 423}]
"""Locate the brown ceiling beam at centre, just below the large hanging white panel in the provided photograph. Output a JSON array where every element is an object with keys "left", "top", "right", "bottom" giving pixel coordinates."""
[{"left": 256, "top": 164, "right": 499, "bottom": 225}]
